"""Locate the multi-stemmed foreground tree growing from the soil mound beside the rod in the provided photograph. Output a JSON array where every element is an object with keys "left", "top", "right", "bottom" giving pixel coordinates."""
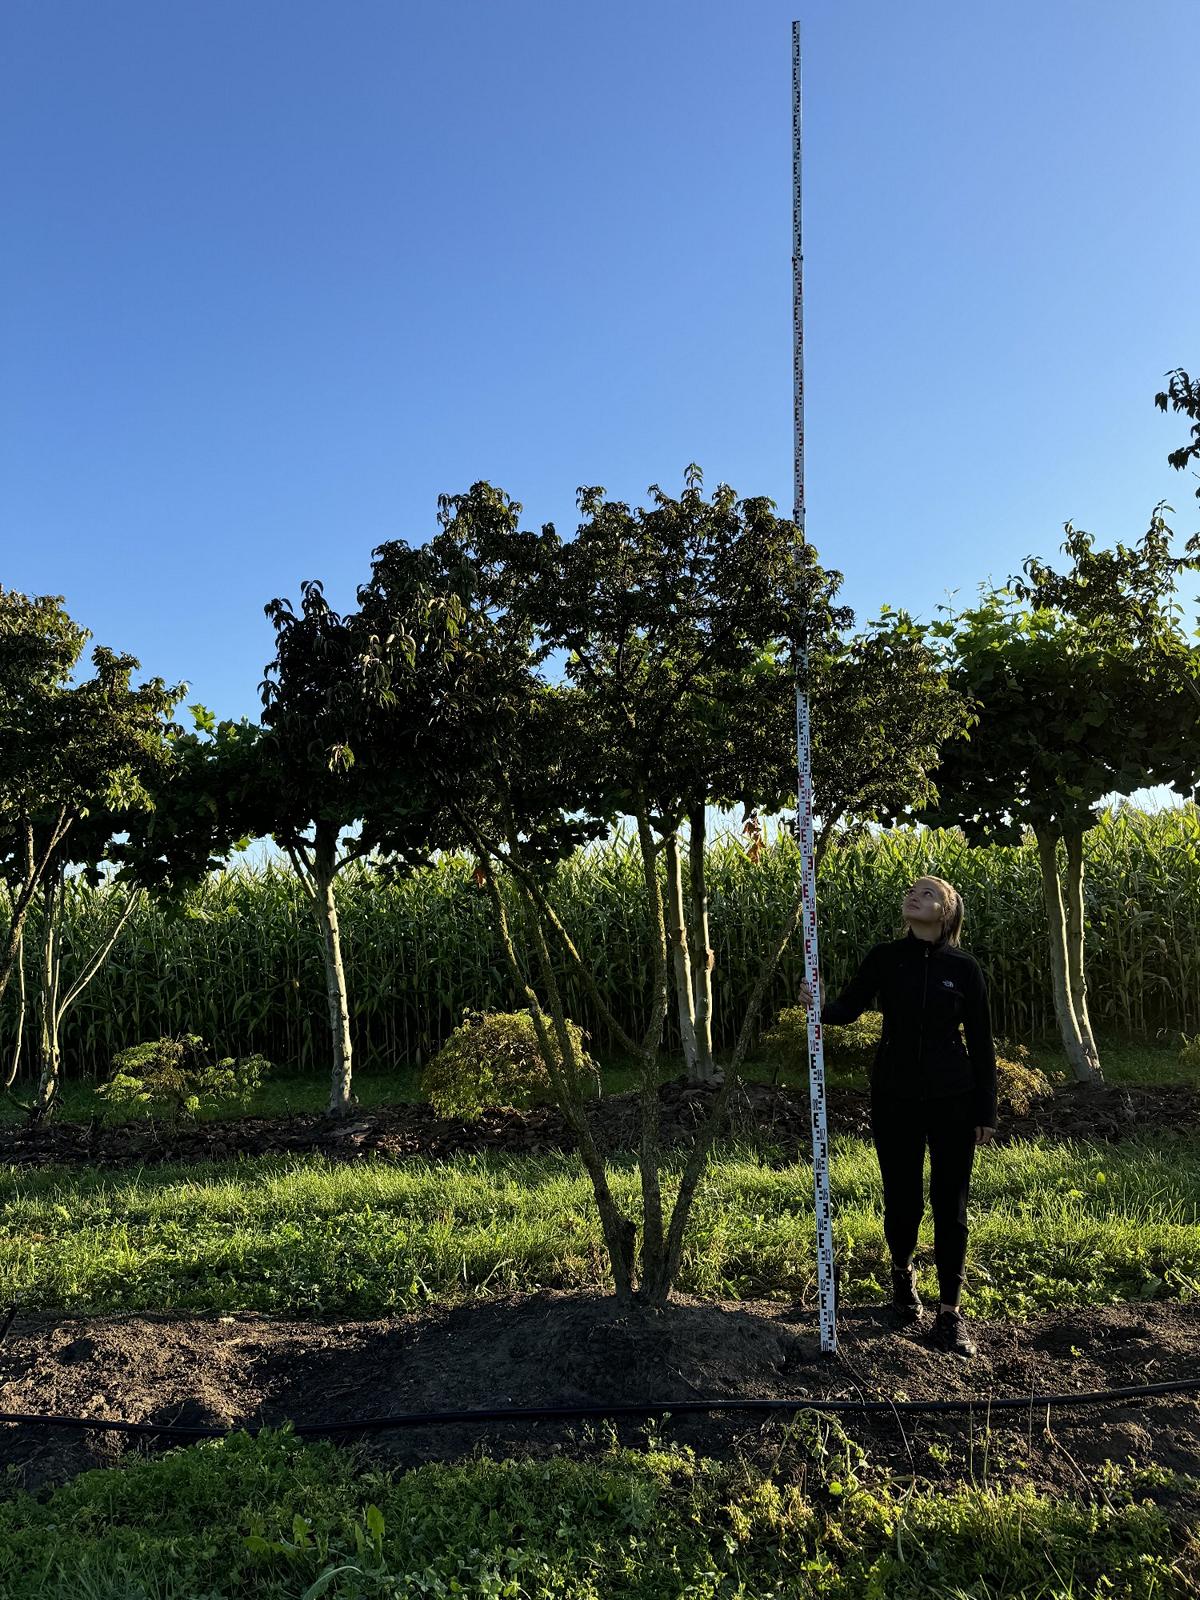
[{"left": 365, "top": 469, "right": 966, "bottom": 1304}]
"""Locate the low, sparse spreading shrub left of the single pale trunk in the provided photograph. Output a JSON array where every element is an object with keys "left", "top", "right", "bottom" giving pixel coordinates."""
[{"left": 96, "top": 1034, "right": 272, "bottom": 1120}]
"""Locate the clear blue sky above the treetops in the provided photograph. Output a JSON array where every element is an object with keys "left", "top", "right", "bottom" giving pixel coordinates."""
[{"left": 0, "top": 0, "right": 1200, "bottom": 793}]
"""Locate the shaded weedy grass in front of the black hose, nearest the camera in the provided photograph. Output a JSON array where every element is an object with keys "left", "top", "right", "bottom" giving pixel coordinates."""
[{"left": 0, "top": 1430, "right": 1197, "bottom": 1600}]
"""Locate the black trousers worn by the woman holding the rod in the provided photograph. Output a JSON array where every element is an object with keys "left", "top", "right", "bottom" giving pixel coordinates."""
[{"left": 870, "top": 1093, "right": 974, "bottom": 1306}]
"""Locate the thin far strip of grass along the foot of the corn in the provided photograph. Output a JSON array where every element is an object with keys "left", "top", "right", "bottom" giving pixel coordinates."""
[{"left": 0, "top": 1038, "right": 1197, "bottom": 1125}]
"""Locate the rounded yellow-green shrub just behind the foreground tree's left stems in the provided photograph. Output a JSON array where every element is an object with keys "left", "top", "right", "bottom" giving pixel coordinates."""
[{"left": 421, "top": 1011, "right": 600, "bottom": 1118}]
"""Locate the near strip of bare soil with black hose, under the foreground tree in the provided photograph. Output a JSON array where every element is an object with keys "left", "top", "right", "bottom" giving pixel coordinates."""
[{"left": 0, "top": 1291, "right": 1200, "bottom": 1517}]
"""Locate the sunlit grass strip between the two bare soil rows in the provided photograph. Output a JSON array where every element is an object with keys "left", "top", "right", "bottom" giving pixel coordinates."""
[{"left": 0, "top": 1138, "right": 1200, "bottom": 1317}]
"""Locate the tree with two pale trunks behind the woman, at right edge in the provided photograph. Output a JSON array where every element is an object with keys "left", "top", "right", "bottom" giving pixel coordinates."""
[{"left": 917, "top": 512, "right": 1200, "bottom": 1082}]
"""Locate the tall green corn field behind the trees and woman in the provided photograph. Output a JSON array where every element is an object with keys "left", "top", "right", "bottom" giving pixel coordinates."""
[{"left": 0, "top": 805, "right": 1200, "bottom": 1077}]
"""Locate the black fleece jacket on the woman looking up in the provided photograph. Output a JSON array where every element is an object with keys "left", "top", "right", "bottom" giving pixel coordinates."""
[{"left": 821, "top": 931, "right": 997, "bottom": 1128}]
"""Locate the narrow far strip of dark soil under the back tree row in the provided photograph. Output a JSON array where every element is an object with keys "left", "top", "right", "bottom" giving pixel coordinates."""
[{"left": 0, "top": 1078, "right": 1200, "bottom": 1166}]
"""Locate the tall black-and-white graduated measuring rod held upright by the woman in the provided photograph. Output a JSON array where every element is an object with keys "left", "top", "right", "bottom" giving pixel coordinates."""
[{"left": 792, "top": 22, "right": 837, "bottom": 1355}]
